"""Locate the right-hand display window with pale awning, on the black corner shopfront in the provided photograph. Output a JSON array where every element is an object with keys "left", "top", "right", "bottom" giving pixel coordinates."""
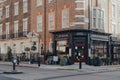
[{"left": 90, "top": 33, "right": 110, "bottom": 58}]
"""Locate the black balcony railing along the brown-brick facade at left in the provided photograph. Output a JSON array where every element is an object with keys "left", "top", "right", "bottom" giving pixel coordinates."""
[{"left": 0, "top": 31, "right": 28, "bottom": 40}]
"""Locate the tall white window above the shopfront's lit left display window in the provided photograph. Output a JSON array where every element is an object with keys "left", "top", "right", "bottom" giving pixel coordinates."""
[{"left": 62, "top": 8, "right": 69, "bottom": 28}]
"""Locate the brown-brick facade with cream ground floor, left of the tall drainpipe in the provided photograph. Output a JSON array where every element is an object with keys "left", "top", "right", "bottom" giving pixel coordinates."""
[{"left": 0, "top": 0, "right": 44, "bottom": 58}]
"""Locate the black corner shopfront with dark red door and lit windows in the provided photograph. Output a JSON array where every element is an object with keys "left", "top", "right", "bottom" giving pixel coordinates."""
[{"left": 52, "top": 29, "right": 109, "bottom": 63}]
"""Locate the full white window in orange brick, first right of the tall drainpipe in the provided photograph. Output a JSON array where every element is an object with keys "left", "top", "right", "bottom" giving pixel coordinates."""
[{"left": 48, "top": 12, "right": 55, "bottom": 30}]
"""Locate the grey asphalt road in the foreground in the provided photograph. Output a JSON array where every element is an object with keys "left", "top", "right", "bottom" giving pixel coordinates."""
[{"left": 0, "top": 65, "right": 120, "bottom": 80}]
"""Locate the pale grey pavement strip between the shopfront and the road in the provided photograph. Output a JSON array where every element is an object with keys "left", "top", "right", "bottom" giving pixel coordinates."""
[{"left": 0, "top": 62, "right": 120, "bottom": 72}]
